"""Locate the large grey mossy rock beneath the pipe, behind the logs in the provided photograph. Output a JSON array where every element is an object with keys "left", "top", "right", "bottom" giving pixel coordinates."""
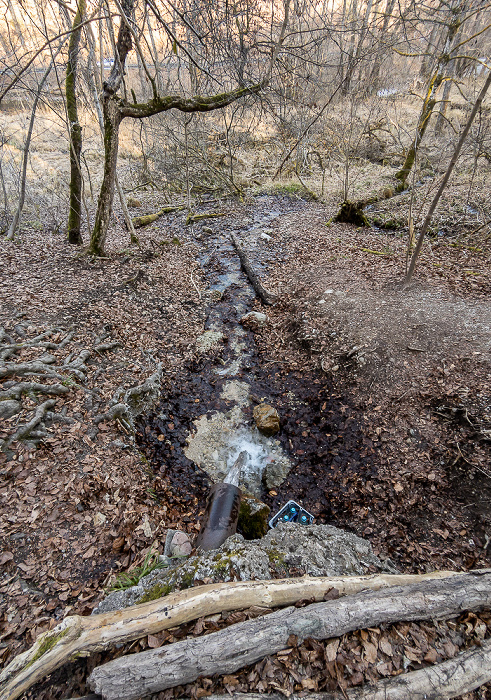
[{"left": 94, "top": 523, "right": 394, "bottom": 614}]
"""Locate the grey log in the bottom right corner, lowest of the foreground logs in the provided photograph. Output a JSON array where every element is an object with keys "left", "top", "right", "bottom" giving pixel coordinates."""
[{"left": 213, "top": 639, "right": 491, "bottom": 700}]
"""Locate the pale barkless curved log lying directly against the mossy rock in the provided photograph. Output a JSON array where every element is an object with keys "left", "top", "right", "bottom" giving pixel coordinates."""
[{"left": 0, "top": 571, "right": 466, "bottom": 700}]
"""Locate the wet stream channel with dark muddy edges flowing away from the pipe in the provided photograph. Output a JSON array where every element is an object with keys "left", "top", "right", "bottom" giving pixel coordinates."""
[{"left": 138, "top": 195, "right": 371, "bottom": 526}]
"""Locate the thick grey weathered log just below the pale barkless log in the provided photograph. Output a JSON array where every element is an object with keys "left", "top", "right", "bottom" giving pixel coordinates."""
[{"left": 89, "top": 572, "right": 491, "bottom": 700}]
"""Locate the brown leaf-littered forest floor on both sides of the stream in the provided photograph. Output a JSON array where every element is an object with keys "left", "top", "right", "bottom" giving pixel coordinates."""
[{"left": 0, "top": 189, "right": 491, "bottom": 699}]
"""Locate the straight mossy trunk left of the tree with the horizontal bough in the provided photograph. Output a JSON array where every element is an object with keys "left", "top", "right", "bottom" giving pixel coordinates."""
[{"left": 65, "top": 0, "right": 86, "bottom": 245}]
